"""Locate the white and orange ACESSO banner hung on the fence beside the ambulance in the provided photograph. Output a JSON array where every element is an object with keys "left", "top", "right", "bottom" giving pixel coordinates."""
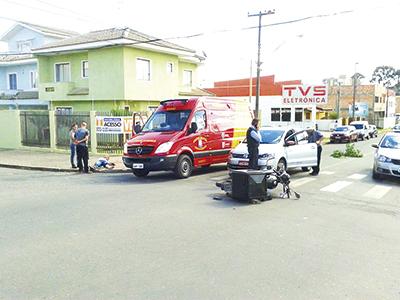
[{"left": 96, "top": 116, "right": 133, "bottom": 134}]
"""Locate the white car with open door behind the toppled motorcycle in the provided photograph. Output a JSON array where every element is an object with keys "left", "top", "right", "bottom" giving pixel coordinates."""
[{"left": 228, "top": 127, "right": 317, "bottom": 171}]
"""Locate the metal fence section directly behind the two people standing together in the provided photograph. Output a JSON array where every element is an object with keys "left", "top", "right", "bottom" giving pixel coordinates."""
[{"left": 55, "top": 112, "right": 90, "bottom": 149}]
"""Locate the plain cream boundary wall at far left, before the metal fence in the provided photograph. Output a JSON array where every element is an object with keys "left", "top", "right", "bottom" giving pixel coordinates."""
[{"left": 0, "top": 110, "right": 21, "bottom": 149}]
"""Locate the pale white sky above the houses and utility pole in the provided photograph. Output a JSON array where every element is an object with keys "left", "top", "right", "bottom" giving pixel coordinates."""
[{"left": 0, "top": 0, "right": 400, "bottom": 87}]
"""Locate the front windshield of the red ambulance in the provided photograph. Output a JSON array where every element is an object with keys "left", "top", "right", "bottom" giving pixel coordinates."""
[{"left": 142, "top": 110, "right": 191, "bottom": 132}]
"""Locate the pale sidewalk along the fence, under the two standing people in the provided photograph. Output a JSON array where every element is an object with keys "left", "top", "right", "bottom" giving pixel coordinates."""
[{"left": 0, "top": 148, "right": 131, "bottom": 173}]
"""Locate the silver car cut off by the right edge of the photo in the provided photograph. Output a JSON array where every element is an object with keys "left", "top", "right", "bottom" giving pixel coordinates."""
[{"left": 372, "top": 132, "right": 400, "bottom": 179}]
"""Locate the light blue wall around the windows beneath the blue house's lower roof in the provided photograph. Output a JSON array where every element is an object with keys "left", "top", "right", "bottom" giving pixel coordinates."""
[{"left": 0, "top": 63, "right": 37, "bottom": 90}]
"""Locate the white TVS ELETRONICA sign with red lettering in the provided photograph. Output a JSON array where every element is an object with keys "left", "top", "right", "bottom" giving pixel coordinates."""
[{"left": 282, "top": 85, "right": 328, "bottom": 105}]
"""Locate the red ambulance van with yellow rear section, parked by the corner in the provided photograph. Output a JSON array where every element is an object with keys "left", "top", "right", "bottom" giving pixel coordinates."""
[{"left": 122, "top": 97, "right": 252, "bottom": 178}]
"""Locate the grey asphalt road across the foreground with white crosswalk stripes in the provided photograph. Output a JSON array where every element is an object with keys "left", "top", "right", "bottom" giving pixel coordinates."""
[{"left": 0, "top": 140, "right": 400, "bottom": 299}]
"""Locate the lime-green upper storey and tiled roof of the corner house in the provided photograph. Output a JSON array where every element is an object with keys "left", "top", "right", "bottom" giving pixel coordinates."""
[{"left": 33, "top": 28, "right": 209, "bottom": 113}]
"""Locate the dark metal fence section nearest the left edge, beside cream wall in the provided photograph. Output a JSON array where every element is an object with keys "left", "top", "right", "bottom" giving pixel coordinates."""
[{"left": 20, "top": 110, "right": 50, "bottom": 147}]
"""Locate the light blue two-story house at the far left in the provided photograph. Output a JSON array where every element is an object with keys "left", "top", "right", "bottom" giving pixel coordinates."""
[{"left": 0, "top": 23, "right": 77, "bottom": 109}]
